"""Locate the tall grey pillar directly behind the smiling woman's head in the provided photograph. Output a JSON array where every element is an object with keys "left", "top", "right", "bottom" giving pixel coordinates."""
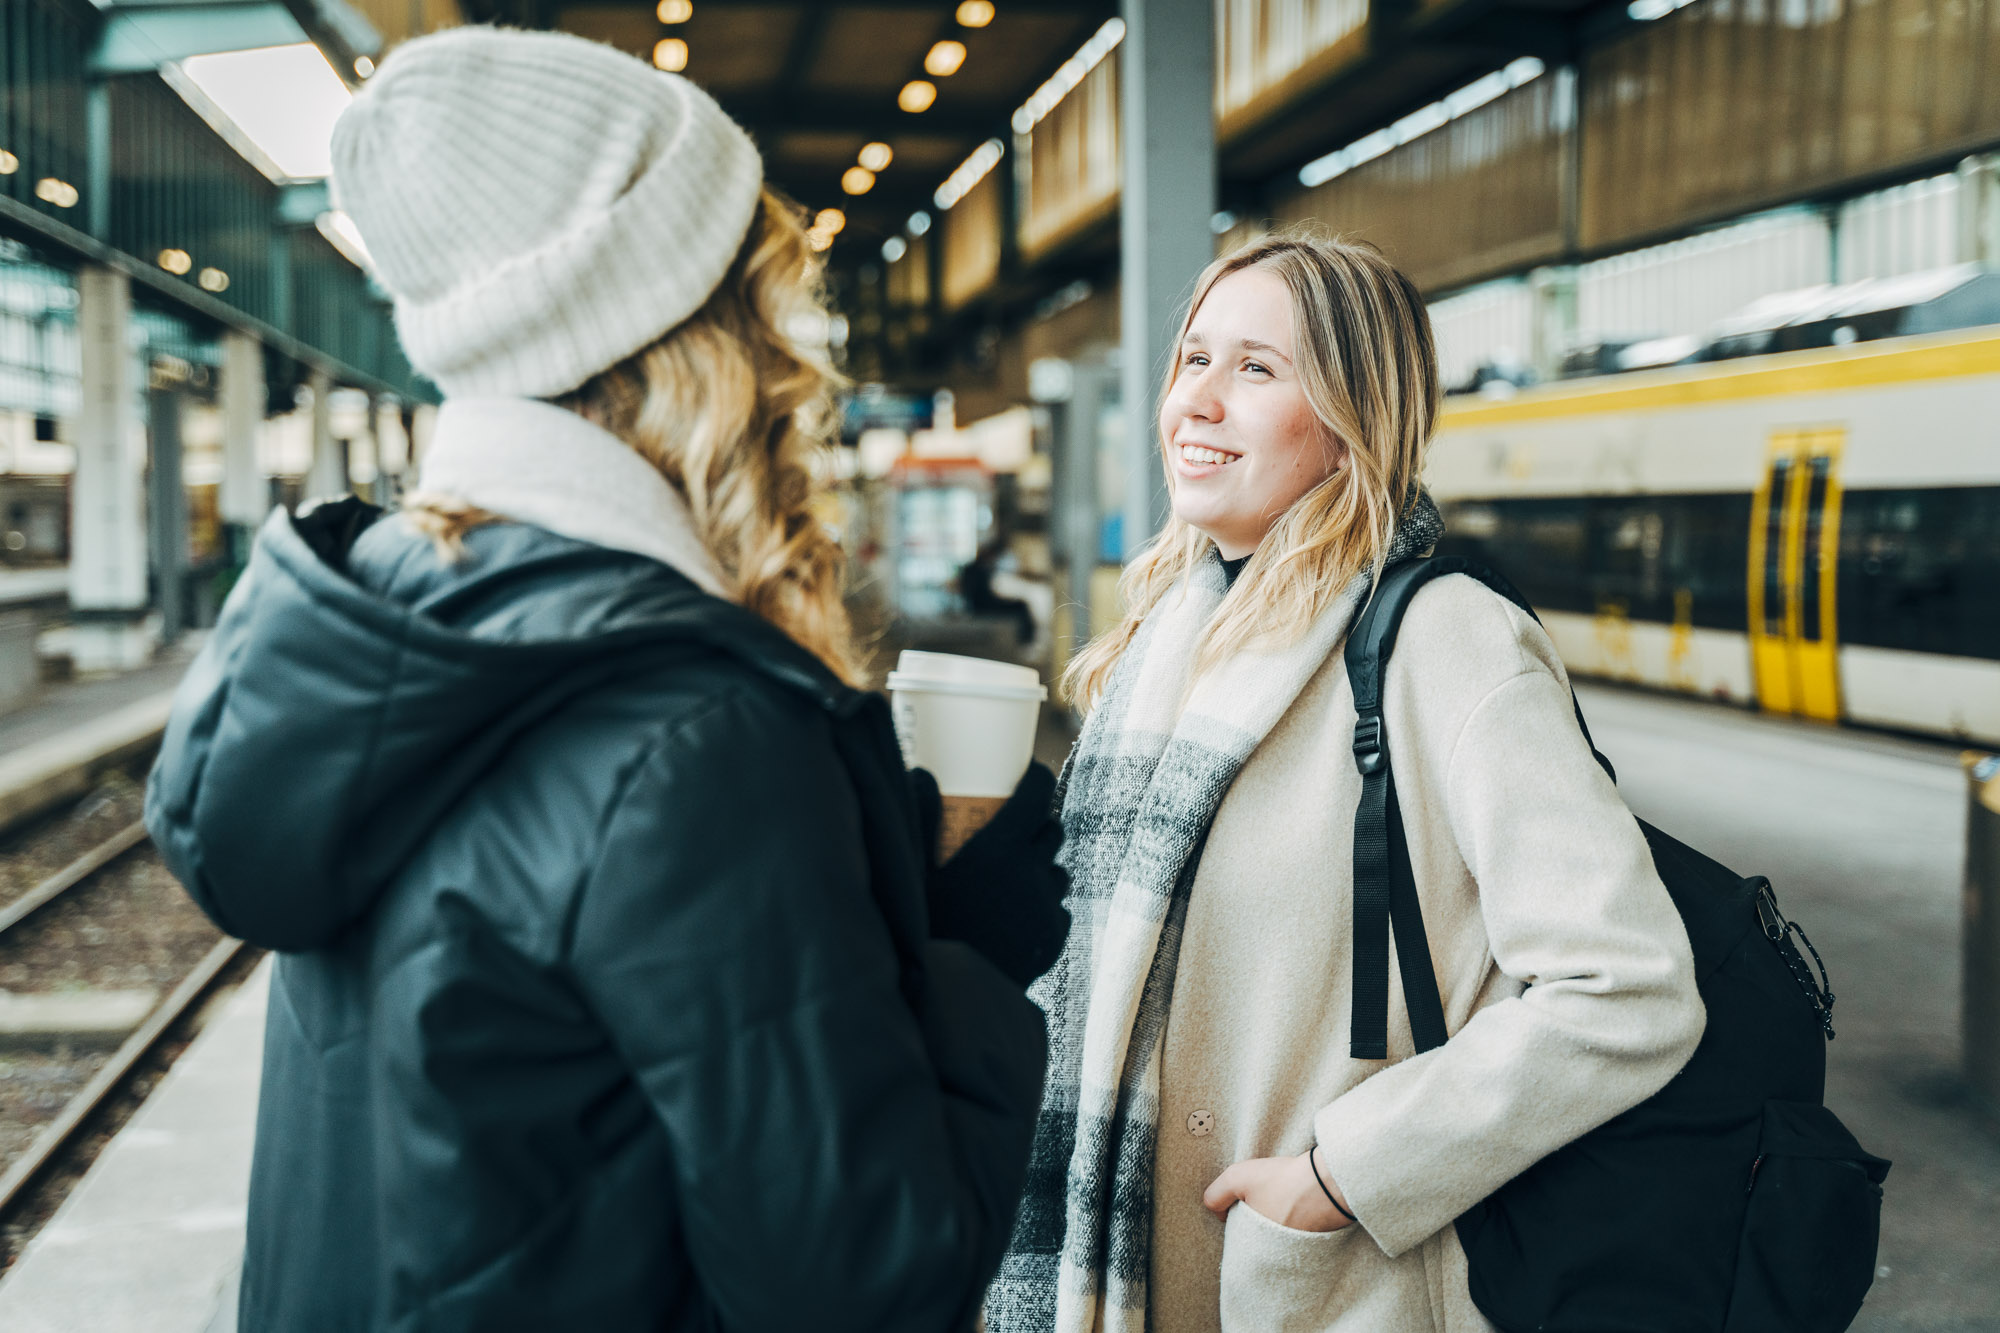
[{"left": 1118, "top": 0, "right": 1216, "bottom": 558}]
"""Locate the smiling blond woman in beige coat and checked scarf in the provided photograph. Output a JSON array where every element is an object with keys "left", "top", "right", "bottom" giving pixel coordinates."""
[{"left": 986, "top": 236, "right": 1704, "bottom": 1333}]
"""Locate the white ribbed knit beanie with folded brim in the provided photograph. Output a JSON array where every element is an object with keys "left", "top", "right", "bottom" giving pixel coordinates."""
[{"left": 332, "top": 28, "right": 764, "bottom": 398}]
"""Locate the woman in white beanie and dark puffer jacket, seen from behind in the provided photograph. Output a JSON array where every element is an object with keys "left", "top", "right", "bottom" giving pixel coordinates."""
[{"left": 148, "top": 28, "right": 1068, "bottom": 1333}]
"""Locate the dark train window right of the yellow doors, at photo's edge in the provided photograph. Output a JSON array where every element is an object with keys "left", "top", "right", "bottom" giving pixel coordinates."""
[{"left": 1838, "top": 486, "right": 2000, "bottom": 660}]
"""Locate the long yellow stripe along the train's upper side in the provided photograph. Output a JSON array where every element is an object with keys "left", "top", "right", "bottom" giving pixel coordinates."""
[{"left": 1440, "top": 328, "right": 2000, "bottom": 430}]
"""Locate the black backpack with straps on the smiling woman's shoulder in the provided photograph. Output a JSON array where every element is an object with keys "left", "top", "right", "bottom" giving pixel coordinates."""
[{"left": 1346, "top": 556, "right": 1890, "bottom": 1333}]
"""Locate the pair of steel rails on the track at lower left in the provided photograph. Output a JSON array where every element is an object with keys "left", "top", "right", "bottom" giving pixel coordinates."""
[{"left": 0, "top": 821, "right": 244, "bottom": 1219}]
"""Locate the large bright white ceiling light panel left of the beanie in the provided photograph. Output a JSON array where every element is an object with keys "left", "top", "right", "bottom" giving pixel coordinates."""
[{"left": 170, "top": 42, "right": 354, "bottom": 180}]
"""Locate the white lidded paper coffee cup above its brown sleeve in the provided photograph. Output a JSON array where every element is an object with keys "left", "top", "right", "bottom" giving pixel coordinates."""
[{"left": 888, "top": 652, "right": 1048, "bottom": 797}]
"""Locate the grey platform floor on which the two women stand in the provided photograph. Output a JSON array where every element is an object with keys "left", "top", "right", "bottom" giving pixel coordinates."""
[{"left": 0, "top": 685, "right": 2000, "bottom": 1333}]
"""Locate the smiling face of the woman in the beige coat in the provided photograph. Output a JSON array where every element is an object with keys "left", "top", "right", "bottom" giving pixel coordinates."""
[{"left": 1160, "top": 268, "right": 1344, "bottom": 560}]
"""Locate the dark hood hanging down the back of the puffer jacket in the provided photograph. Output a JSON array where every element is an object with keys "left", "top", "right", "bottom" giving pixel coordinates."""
[{"left": 146, "top": 500, "right": 864, "bottom": 951}]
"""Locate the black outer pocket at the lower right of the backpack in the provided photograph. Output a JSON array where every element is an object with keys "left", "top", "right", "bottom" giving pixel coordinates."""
[{"left": 1724, "top": 1101, "right": 1890, "bottom": 1333}]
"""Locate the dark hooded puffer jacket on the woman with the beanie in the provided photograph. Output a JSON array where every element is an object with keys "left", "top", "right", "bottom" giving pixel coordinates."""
[{"left": 146, "top": 502, "right": 1044, "bottom": 1333}]
